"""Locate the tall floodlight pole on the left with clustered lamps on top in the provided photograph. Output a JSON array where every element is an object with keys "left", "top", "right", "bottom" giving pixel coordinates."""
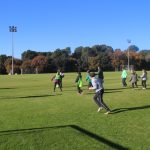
[{"left": 9, "top": 26, "right": 17, "bottom": 75}]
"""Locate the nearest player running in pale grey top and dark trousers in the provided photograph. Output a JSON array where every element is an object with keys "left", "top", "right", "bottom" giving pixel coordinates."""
[{"left": 89, "top": 72, "right": 111, "bottom": 114}]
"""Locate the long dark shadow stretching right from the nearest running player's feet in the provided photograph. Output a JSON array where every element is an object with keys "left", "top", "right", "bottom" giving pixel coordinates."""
[{"left": 112, "top": 105, "right": 150, "bottom": 114}]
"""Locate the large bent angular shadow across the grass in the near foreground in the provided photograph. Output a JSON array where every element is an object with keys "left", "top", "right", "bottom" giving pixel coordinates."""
[{"left": 0, "top": 125, "right": 129, "bottom": 150}]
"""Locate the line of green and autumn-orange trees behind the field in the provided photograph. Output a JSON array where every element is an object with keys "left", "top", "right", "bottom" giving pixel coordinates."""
[{"left": 0, "top": 45, "right": 150, "bottom": 74}]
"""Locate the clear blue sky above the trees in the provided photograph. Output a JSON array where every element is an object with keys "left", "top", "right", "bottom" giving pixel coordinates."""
[{"left": 0, "top": 0, "right": 150, "bottom": 58}]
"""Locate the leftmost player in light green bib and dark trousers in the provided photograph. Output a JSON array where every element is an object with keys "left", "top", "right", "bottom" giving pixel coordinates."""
[{"left": 51, "top": 70, "right": 62, "bottom": 92}]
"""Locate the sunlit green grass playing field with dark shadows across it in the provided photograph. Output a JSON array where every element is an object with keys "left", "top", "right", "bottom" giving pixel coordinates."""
[{"left": 0, "top": 72, "right": 150, "bottom": 150}]
